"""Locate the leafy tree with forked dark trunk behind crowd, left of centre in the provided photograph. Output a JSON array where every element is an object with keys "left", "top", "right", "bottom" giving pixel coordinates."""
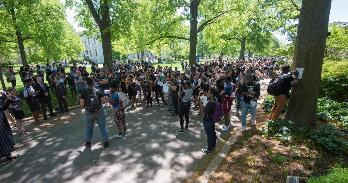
[{"left": 66, "top": 0, "right": 134, "bottom": 69}]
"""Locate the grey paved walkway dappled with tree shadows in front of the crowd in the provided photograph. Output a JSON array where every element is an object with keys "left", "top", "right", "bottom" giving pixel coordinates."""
[{"left": 0, "top": 102, "right": 211, "bottom": 183}]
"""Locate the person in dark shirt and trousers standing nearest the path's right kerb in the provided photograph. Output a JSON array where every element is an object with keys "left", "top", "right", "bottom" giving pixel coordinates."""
[{"left": 202, "top": 88, "right": 219, "bottom": 154}]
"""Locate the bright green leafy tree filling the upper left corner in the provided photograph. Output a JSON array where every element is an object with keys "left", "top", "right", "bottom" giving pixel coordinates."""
[{"left": 0, "top": 0, "right": 83, "bottom": 65}]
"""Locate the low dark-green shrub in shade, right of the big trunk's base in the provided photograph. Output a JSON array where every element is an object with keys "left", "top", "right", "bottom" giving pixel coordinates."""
[{"left": 310, "top": 125, "right": 348, "bottom": 154}]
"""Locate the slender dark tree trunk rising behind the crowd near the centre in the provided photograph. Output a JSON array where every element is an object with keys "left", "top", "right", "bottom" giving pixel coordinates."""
[{"left": 189, "top": 0, "right": 199, "bottom": 65}]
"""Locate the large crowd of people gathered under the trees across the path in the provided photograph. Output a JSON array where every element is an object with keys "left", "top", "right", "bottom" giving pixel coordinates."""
[{"left": 0, "top": 58, "right": 300, "bottom": 164}]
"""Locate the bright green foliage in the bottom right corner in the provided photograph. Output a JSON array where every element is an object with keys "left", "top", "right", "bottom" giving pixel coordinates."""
[{"left": 308, "top": 167, "right": 348, "bottom": 183}]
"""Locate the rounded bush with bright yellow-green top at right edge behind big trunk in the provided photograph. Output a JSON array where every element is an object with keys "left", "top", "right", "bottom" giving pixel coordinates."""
[{"left": 320, "top": 61, "right": 348, "bottom": 102}]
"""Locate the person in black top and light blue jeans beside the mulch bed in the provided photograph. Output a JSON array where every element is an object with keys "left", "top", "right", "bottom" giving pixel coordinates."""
[{"left": 241, "top": 75, "right": 260, "bottom": 131}]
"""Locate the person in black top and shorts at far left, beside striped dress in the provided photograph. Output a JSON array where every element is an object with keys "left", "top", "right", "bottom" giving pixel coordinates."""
[{"left": 7, "top": 87, "right": 27, "bottom": 135}]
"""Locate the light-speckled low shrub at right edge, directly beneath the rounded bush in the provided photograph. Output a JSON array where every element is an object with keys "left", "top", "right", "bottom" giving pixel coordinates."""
[{"left": 317, "top": 97, "right": 348, "bottom": 129}]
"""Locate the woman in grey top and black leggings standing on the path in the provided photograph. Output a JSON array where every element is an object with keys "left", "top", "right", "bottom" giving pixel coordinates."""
[{"left": 177, "top": 80, "right": 193, "bottom": 133}]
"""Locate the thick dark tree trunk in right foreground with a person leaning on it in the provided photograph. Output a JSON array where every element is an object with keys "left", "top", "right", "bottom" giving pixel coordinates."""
[{"left": 286, "top": 0, "right": 331, "bottom": 126}]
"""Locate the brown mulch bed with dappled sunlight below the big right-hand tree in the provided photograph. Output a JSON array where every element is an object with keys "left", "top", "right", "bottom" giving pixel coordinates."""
[{"left": 210, "top": 109, "right": 346, "bottom": 183}]
